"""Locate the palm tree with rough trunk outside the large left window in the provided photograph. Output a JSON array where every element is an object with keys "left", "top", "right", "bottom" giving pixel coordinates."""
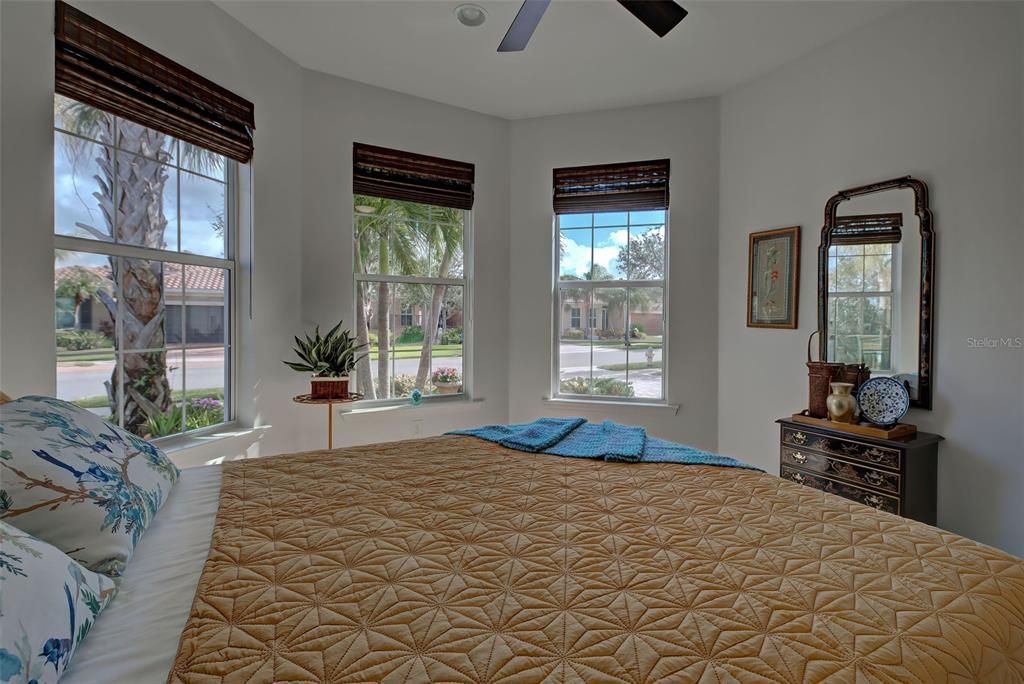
[{"left": 55, "top": 97, "right": 222, "bottom": 432}]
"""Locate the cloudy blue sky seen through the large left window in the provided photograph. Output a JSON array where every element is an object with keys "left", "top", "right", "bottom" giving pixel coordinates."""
[{"left": 53, "top": 131, "right": 225, "bottom": 260}]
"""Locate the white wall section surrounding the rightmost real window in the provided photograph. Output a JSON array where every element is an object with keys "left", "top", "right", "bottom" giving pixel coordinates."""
[{"left": 509, "top": 99, "right": 718, "bottom": 448}]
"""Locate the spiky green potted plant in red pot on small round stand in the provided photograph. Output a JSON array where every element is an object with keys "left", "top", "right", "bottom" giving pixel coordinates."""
[{"left": 285, "top": 322, "right": 369, "bottom": 400}]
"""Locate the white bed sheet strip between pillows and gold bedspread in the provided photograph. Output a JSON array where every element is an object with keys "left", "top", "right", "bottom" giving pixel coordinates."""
[{"left": 61, "top": 466, "right": 220, "bottom": 684}]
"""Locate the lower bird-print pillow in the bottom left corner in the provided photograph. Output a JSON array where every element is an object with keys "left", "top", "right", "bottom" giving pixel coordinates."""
[{"left": 0, "top": 521, "right": 117, "bottom": 684}]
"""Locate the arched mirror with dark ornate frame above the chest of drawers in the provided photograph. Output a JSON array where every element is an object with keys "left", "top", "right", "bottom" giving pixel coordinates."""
[{"left": 818, "top": 176, "right": 935, "bottom": 409}]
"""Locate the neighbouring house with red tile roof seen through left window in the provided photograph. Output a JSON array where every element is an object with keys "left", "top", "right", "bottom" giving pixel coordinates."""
[{"left": 54, "top": 263, "right": 225, "bottom": 346}]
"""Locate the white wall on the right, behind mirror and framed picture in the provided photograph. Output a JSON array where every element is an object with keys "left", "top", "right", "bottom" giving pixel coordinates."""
[{"left": 718, "top": 3, "right": 1024, "bottom": 555}]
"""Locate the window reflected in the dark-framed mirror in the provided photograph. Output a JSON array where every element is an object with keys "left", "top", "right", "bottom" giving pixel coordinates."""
[{"left": 828, "top": 243, "right": 898, "bottom": 372}]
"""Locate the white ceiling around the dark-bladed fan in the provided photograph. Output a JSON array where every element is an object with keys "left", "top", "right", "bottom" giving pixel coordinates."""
[{"left": 215, "top": 0, "right": 894, "bottom": 119}]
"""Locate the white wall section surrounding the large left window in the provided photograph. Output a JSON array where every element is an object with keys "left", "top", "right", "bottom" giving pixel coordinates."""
[{"left": 0, "top": 0, "right": 302, "bottom": 463}]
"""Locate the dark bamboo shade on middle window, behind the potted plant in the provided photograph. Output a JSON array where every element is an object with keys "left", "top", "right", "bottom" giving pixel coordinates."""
[{"left": 352, "top": 142, "right": 476, "bottom": 209}]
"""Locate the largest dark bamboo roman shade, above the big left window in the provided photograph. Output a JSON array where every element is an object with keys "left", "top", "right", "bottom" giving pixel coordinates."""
[{"left": 55, "top": 0, "right": 255, "bottom": 163}]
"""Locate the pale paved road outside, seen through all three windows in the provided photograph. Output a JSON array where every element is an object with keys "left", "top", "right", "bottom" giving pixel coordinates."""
[{"left": 57, "top": 342, "right": 662, "bottom": 401}]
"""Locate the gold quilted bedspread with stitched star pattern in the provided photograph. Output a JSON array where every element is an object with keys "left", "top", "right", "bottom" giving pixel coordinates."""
[{"left": 169, "top": 437, "right": 1024, "bottom": 683}]
